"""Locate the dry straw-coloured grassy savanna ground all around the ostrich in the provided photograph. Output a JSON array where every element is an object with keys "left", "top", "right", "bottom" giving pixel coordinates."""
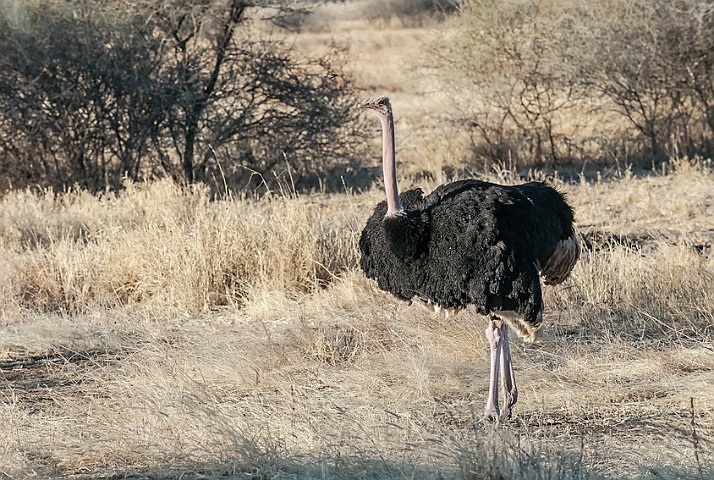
[{"left": 0, "top": 4, "right": 714, "bottom": 479}]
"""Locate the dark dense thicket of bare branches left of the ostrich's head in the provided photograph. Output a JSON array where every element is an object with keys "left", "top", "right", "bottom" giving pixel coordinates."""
[{"left": 0, "top": 0, "right": 358, "bottom": 195}]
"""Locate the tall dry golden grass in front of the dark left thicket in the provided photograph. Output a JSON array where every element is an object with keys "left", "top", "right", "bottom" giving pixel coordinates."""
[{"left": 0, "top": 181, "right": 358, "bottom": 313}]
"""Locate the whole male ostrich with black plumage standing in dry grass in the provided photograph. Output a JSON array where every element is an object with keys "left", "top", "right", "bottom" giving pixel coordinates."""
[{"left": 359, "top": 97, "right": 580, "bottom": 422}]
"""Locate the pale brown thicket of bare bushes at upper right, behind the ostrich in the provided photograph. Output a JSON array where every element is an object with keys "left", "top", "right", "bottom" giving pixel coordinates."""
[{"left": 437, "top": 0, "right": 714, "bottom": 169}]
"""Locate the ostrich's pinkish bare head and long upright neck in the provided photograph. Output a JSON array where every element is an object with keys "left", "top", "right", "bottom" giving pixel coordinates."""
[{"left": 360, "top": 96, "right": 404, "bottom": 217}]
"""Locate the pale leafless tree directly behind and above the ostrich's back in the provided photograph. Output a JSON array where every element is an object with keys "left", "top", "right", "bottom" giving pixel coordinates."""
[{"left": 436, "top": 0, "right": 582, "bottom": 164}]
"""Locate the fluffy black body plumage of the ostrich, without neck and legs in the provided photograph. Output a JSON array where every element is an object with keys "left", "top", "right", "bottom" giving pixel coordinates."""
[{"left": 360, "top": 180, "right": 574, "bottom": 325}]
